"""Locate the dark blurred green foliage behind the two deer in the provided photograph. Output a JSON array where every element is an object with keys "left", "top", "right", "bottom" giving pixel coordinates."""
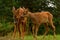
[{"left": 0, "top": 0, "right": 60, "bottom": 34}]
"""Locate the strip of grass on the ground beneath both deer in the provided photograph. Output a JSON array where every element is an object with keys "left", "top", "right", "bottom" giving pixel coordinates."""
[{"left": 0, "top": 33, "right": 60, "bottom": 40}]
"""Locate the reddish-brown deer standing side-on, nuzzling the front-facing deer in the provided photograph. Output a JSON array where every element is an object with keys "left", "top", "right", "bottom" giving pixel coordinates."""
[{"left": 25, "top": 9, "right": 55, "bottom": 39}]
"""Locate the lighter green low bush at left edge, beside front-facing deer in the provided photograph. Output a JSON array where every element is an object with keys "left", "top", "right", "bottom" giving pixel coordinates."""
[{"left": 0, "top": 22, "right": 13, "bottom": 36}]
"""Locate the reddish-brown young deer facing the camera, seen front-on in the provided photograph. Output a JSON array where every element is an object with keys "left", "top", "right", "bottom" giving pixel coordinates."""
[{"left": 12, "top": 7, "right": 26, "bottom": 40}]
